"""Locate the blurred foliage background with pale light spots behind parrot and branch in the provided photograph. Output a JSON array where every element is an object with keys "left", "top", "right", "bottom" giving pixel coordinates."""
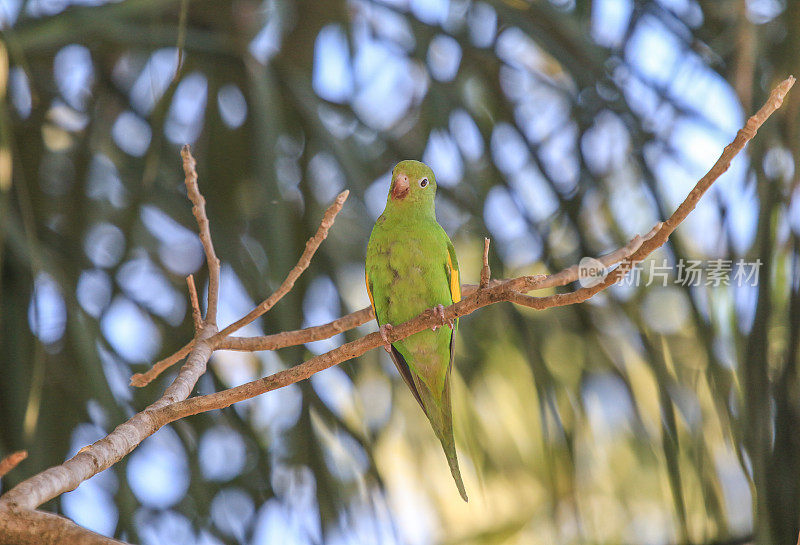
[{"left": 0, "top": 0, "right": 800, "bottom": 545}]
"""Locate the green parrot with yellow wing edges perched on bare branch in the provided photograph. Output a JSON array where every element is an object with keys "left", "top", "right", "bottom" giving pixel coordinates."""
[{"left": 365, "top": 161, "right": 467, "bottom": 501}]
